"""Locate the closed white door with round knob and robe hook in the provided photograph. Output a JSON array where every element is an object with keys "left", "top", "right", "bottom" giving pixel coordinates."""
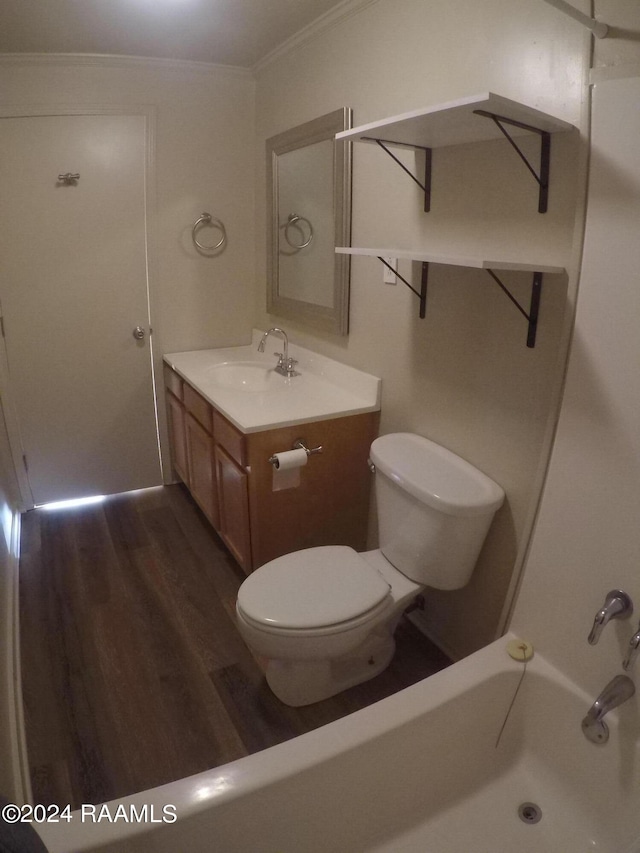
[{"left": 0, "top": 115, "right": 161, "bottom": 505}]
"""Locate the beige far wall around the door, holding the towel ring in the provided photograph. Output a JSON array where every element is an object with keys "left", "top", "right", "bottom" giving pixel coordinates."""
[{"left": 0, "top": 57, "right": 254, "bottom": 351}]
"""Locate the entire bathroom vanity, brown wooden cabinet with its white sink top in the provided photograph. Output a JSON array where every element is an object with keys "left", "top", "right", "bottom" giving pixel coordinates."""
[{"left": 164, "top": 330, "right": 381, "bottom": 573}]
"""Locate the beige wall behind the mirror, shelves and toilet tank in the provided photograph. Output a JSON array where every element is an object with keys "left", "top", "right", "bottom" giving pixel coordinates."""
[{"left": 256, "top": 0, "right": 589, "bottom": 656}]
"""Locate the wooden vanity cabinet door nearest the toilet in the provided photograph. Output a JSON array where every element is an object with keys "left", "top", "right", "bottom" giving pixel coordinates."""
[{"left": 215, "top": 445, "right": 251, "bottom": 573}]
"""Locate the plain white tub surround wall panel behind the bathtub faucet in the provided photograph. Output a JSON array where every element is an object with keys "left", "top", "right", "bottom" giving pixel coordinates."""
[{"left": 513, "top": 75, "right": 640, "bottom": 700}]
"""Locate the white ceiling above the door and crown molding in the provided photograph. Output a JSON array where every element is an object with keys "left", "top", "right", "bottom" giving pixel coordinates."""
[{"left": 0, "top": 0, "right": 345, "bottom": 68}]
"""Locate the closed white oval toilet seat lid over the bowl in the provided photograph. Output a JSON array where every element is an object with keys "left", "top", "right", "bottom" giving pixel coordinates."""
[{"left": 237, "top": 545, "right": 392, "bottom": 636}]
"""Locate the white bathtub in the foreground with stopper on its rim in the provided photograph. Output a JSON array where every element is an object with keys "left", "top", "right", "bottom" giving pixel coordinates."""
[{"left": 39, "top": 637, "right": 640, "bottom": 853}]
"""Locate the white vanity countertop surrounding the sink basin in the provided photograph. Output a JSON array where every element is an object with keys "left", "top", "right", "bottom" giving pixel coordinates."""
[{"left": 164, "top": 329, "right": 382, "bottom": 433}]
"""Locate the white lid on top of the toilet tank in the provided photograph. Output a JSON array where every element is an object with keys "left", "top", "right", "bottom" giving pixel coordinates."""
[{"left": 371, "top": 432, "right": 504, "bottom": 516}]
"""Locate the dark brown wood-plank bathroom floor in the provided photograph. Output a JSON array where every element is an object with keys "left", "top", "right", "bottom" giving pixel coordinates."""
[{"left": 20, "top": 486, "right": 449, "bottom": 807}]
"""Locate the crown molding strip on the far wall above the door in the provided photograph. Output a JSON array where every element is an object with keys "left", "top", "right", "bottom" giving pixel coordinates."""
[{"left": 0, "top": 53, "right": 253, "bottom": 79}]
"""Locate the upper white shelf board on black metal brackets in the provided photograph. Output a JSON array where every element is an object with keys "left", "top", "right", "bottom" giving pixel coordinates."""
[{"left": 336, "top": 92, "right": 573, "bottom": 148}]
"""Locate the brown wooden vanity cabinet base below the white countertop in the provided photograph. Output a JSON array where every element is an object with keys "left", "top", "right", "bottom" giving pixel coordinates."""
[{"left": 165, "top": 367, "right": 379, "bottom": 574}]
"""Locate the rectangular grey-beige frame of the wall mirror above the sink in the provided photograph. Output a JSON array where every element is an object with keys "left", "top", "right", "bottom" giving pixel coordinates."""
[{"left": 266, "top": 107, "right": 352, "bottom": 335}]
